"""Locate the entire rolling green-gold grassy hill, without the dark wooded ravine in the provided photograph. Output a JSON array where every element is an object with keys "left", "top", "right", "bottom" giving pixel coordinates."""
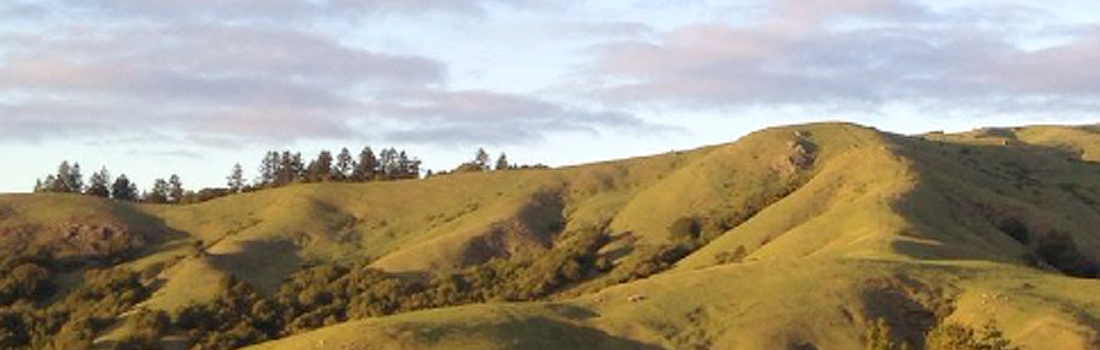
[{"left": 0, "top": 123, "right": 1100, "bottom": 349}]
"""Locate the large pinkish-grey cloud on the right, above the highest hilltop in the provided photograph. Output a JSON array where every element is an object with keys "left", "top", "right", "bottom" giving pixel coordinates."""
[{"left": 569, "top": 0, "right": 1100, "bottom": 115}]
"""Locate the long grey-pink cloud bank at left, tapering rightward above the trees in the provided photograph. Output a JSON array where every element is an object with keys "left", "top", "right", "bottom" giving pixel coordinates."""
[{"left": 0, "top": 5, "right": 649, "bottom": 147}]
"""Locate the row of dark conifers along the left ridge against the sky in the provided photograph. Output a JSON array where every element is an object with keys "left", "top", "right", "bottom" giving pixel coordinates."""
[{"left": 34, "top": 146, "right": 548, "bottom": 204}]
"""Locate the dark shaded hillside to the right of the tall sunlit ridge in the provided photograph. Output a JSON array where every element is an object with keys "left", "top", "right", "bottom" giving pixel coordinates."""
[{"left": 892, "top": 134, "right": 1100, "bottom": 277}]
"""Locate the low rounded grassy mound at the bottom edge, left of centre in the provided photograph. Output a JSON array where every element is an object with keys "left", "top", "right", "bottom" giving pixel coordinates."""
[{"left": 244, "top": 304, "right": 659, "bottom": 350}]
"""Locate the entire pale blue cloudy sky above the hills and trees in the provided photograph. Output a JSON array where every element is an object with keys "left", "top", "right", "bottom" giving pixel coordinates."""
[{"left": 0, "top": 0, "right": 1100, "bottom": 193}]
